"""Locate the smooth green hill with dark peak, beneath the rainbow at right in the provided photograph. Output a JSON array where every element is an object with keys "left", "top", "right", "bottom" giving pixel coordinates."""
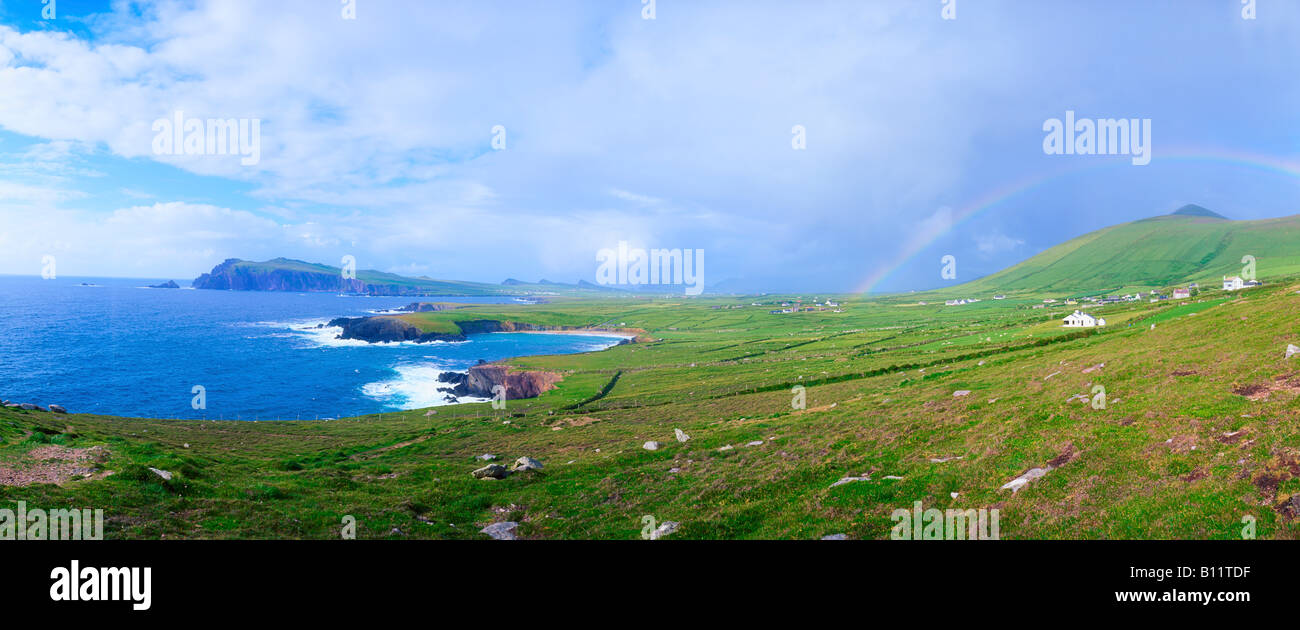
[{"left": 944, "top": 205, "right": 1300, "bottom": 295}]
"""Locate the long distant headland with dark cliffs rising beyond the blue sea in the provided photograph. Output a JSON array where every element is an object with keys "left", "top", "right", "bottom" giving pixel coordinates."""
[{"left": 192, "top": 258, "right": 516, "bottom": 296}]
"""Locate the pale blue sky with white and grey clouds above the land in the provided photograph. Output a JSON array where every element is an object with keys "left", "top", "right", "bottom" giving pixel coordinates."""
[{"left": 0, "top": 0, "right": 1300, "bottom": 292}]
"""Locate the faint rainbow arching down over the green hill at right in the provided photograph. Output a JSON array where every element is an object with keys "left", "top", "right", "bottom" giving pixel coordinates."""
[{"left": 854, "top": 148, "right": 1300, "bottom": 294}]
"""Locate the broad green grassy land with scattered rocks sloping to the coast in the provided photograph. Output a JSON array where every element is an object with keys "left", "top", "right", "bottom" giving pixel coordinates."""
[{"left": 0, "top": 272, "right": 1300, "bottom": 539}]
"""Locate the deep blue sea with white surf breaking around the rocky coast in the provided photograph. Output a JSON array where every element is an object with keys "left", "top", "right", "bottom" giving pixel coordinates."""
[{"left": 0, "top": 275, "right": 629, "bottom": 420}]
